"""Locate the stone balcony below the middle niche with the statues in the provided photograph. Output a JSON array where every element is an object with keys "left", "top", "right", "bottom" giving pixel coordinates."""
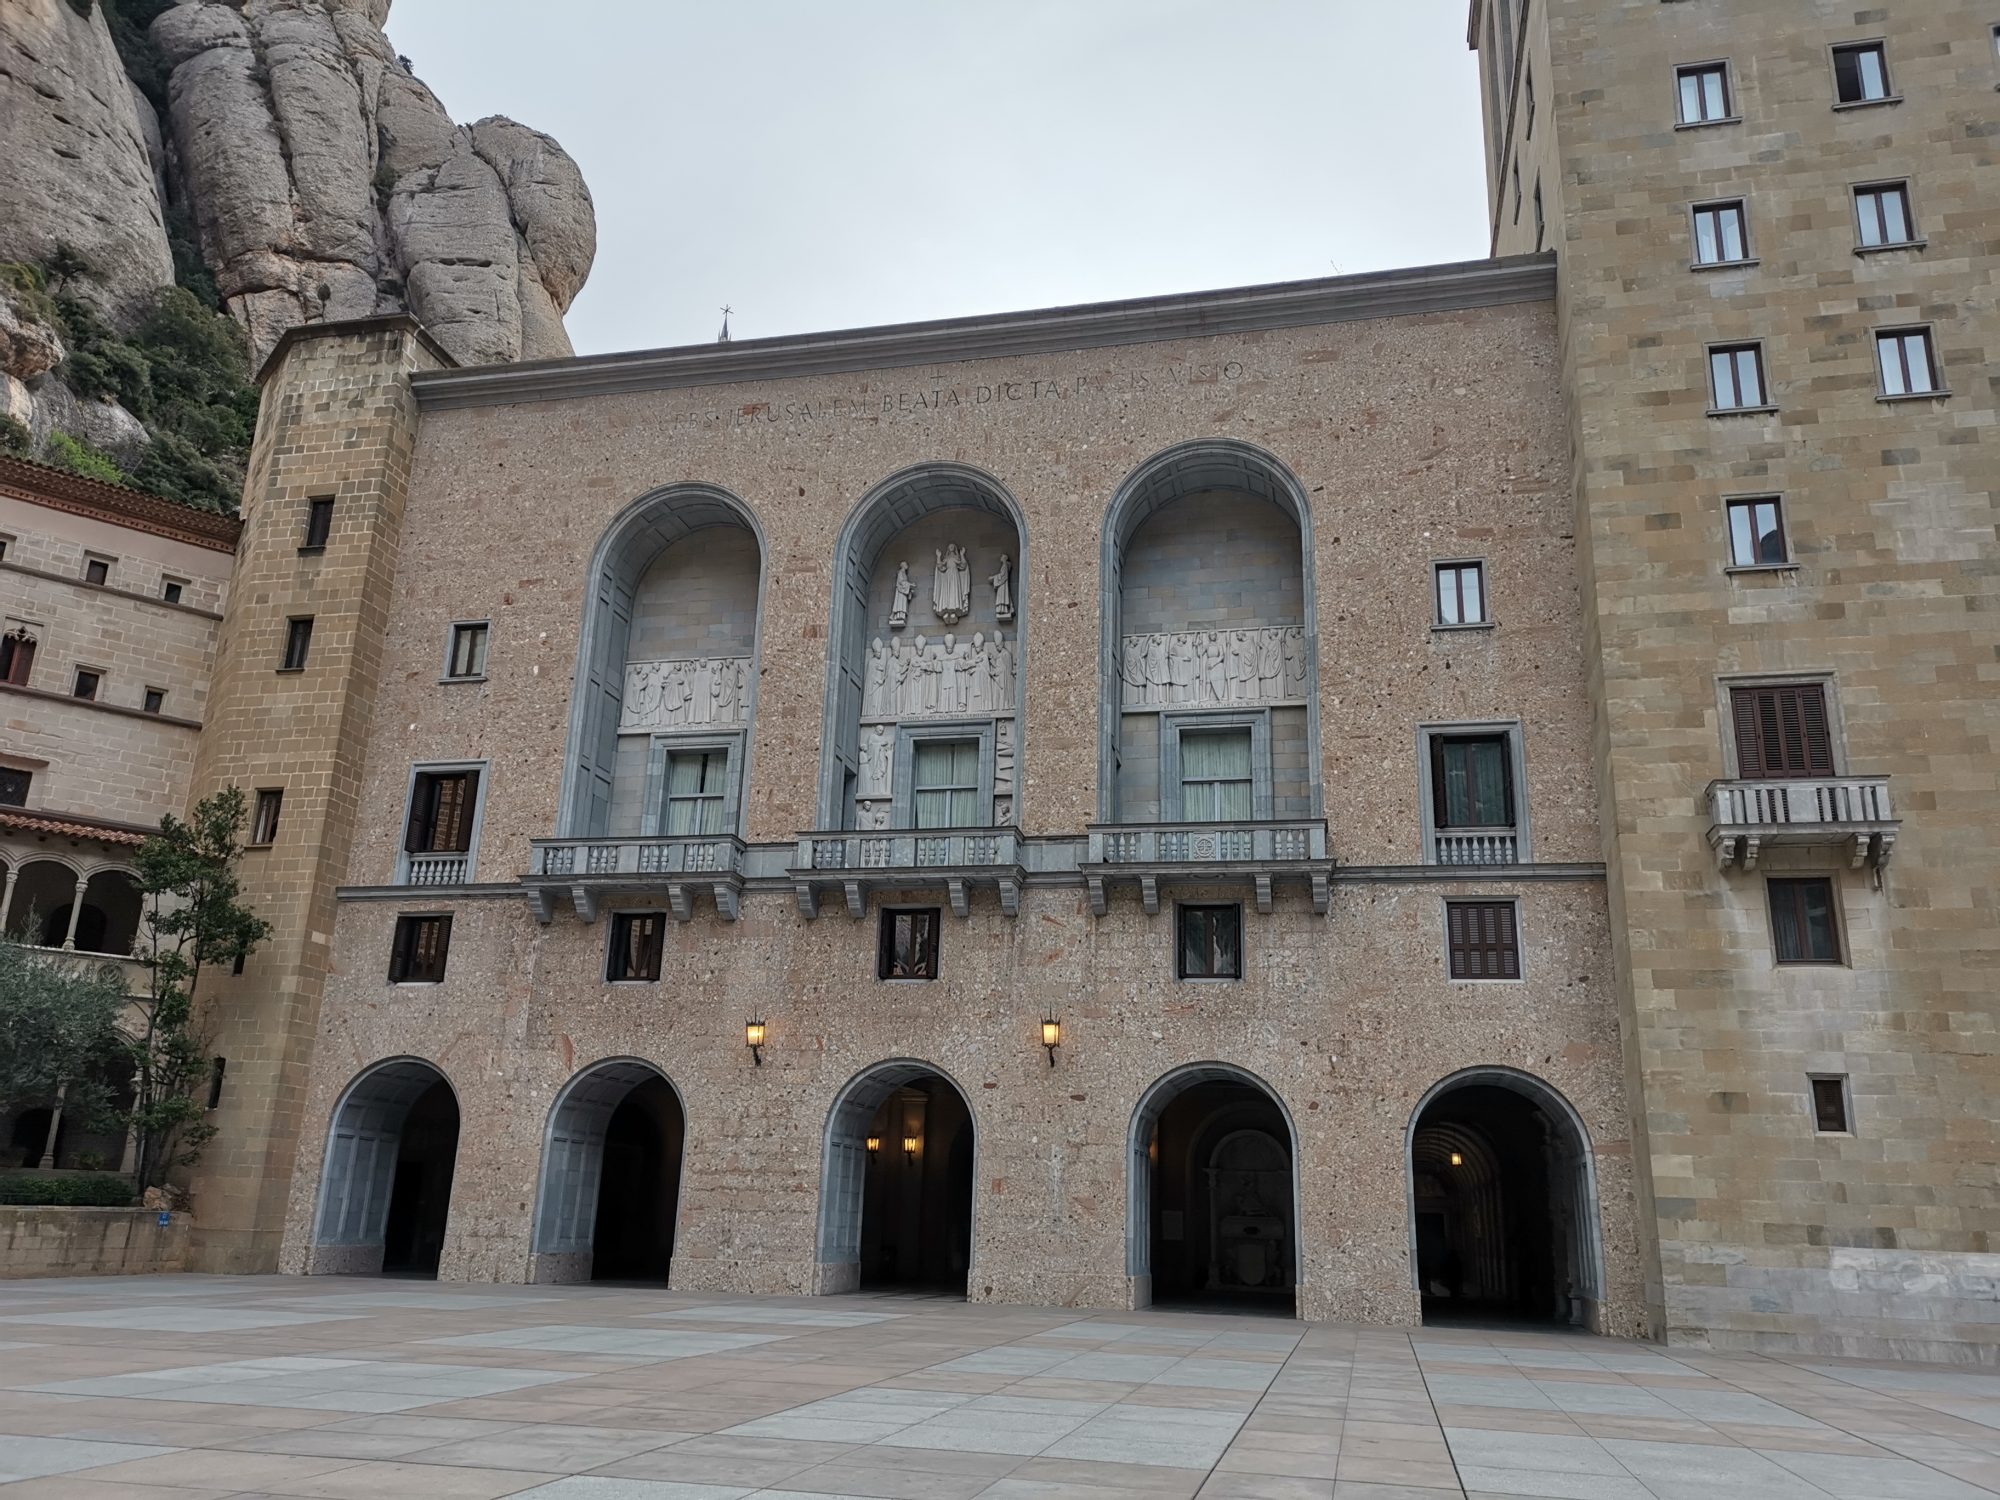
[{"left": 786, "top": 828, "right": 1026, "bottom": 920}]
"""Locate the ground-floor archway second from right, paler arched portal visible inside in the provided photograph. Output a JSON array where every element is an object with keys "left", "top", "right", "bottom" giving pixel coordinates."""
[{"left": 1126, "top": 1062, "right": 1302, "bottom": 1316}]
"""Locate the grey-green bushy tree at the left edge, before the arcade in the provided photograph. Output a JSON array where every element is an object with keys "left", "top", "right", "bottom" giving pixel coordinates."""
[{"left": 0, "top": 940, "right": 126, "bottom": 1118}]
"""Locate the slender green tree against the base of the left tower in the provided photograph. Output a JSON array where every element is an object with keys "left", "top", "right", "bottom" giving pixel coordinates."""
[{"left": 128, "top": 786, "right": 270, "bottom": 1190}]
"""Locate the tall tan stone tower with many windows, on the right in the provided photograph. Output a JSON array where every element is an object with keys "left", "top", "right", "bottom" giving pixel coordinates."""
[{"left": 1470, "top": 0, "right": 2000, "bottom": 1358}]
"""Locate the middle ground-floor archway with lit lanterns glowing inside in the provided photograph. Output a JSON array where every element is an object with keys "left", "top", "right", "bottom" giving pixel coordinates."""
[{"left": 816, "top": 1060, "right": 978, "bottom": 1296}]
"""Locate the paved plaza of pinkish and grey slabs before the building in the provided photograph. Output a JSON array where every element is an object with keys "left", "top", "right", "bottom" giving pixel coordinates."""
[{"left": 0, "top": 1276, "right": 2000, "bottom": 1500}]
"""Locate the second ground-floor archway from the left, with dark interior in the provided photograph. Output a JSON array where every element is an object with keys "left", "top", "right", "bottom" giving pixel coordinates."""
[{"left": 528, "top": 1058, "right": 688, "bottom": 1284}]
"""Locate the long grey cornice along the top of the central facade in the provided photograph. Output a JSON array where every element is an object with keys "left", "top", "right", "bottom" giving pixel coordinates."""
[{"left": 412, "top": 254, "right": 1556, "bottom": 410}]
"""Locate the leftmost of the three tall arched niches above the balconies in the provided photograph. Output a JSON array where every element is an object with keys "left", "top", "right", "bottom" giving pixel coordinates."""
[{"left": 560, "top": 494, "right": 766, "bottom": 838}]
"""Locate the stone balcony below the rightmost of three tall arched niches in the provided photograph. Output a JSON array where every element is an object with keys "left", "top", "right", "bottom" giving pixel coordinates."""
[{"left": 1080, "top": 818, "right": 1334, "bottom": 916}]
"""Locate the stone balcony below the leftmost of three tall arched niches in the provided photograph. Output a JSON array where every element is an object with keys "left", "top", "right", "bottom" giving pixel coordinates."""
[{"left": 524, "top": 834, "right": 744, "bottom": 922}]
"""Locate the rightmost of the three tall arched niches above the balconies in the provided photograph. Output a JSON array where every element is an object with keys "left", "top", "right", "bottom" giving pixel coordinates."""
[{"left": 1098, "top": 440, "right": 1324, "bottom": 822}]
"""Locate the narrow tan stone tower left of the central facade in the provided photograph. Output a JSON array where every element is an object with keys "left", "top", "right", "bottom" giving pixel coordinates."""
[{"left": 194, "top": 316, "right": 450, "bottom": 1272}]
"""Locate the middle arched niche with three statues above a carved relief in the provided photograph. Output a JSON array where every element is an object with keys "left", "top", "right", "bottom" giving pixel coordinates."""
[{"left": 818, "top": 464, "right": 1028, "bottom": 830}]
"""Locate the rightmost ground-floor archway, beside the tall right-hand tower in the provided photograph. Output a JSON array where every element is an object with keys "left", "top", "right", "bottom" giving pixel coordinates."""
[{"left": 1410, "top": 1068, "right": 1602, "bottom": 1328}]
